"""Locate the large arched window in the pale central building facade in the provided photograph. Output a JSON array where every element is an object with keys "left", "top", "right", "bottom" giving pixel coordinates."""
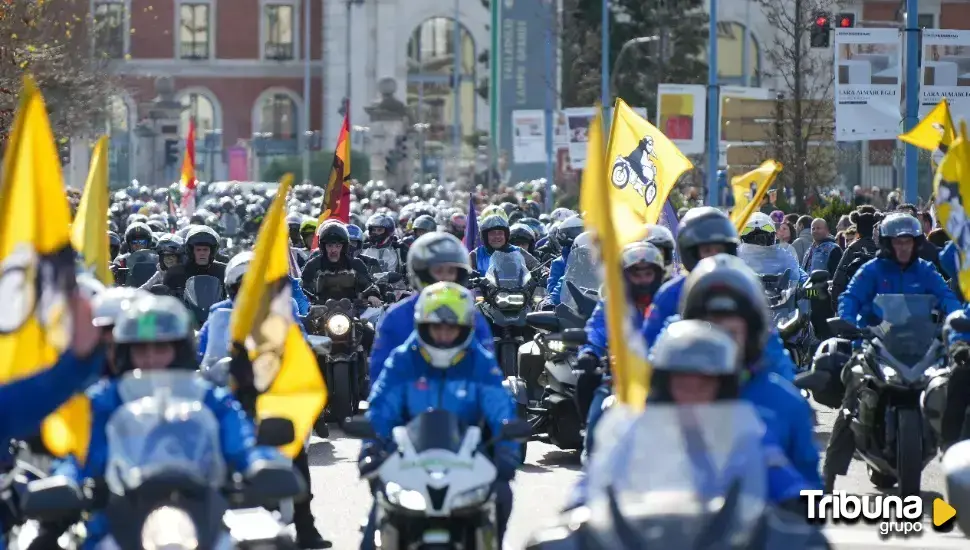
[{"left": 407, "top": 17, "right": 478, "bottom": 146}]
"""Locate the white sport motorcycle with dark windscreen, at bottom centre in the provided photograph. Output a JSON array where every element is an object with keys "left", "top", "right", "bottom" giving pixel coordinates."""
[{"left": 360, "top": 410, "right": 531, "bottom": 550}]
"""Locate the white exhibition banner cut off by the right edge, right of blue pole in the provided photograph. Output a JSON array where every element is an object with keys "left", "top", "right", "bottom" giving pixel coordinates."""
[{"left": 919, "top": 29, "right": 970, "bottom": 122}]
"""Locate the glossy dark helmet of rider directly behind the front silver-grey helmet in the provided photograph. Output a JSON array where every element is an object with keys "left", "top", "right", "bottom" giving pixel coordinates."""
[{"left": 680, "top": 254, "right": 772, "bottom": 365}]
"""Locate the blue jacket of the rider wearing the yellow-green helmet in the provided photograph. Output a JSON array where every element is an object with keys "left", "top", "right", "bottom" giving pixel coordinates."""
[{"left": 367, "top": 333, "right": 522, "bottom": 477}]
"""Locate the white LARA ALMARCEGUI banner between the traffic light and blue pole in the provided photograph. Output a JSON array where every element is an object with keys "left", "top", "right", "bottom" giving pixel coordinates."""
[{"left": 833, "top": 28, "right": 903, "bottom": 141}]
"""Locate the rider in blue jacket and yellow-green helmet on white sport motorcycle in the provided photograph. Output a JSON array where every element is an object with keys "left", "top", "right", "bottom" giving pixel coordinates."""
[{"left": 361, "top": 282, "right": 522, "bottom": 548}]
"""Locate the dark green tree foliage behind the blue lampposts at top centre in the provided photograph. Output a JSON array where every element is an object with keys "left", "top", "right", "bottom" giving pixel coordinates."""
[{"left": 561, "top": 0, "right": 708, "bottom": 115}]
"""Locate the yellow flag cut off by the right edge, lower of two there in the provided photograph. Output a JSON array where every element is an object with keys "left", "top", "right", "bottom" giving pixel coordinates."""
[{"left": 933, "top": 125, "right": 970, "bottom": 300}]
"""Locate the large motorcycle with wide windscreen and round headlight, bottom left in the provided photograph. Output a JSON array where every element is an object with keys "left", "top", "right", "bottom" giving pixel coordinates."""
[{"left": 23, "top": 371, "right": 306, "bottom": 550}]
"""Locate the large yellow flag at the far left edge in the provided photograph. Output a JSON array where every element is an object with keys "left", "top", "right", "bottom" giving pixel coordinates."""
[{"left": 0, "top": 77, "right": 75, "bottom": 383}]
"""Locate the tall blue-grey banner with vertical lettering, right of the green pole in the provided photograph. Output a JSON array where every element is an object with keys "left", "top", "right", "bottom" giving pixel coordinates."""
[{"left": 493, "top": 0, "right": 559, "bottom": 181}]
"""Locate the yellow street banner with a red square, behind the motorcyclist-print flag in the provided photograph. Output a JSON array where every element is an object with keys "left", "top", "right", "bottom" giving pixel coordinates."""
[{"left": 657, "top": 84, "right": 707, "bottom": 155}]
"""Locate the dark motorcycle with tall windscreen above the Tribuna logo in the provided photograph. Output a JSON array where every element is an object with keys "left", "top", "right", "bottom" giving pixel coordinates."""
[{"left": 825, "top": 294, "right": 948, "bottom": 497}]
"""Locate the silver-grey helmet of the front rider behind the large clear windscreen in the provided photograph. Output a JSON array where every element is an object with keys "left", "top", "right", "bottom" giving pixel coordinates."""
[{"left": 649, "top": 320, "right": 741, "bottom": 403}]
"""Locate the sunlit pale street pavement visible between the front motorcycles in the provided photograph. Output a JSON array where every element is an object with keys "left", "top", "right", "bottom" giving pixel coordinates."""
[{"left": 310, "top": 408, "right": 970, "bottom": 550}]
